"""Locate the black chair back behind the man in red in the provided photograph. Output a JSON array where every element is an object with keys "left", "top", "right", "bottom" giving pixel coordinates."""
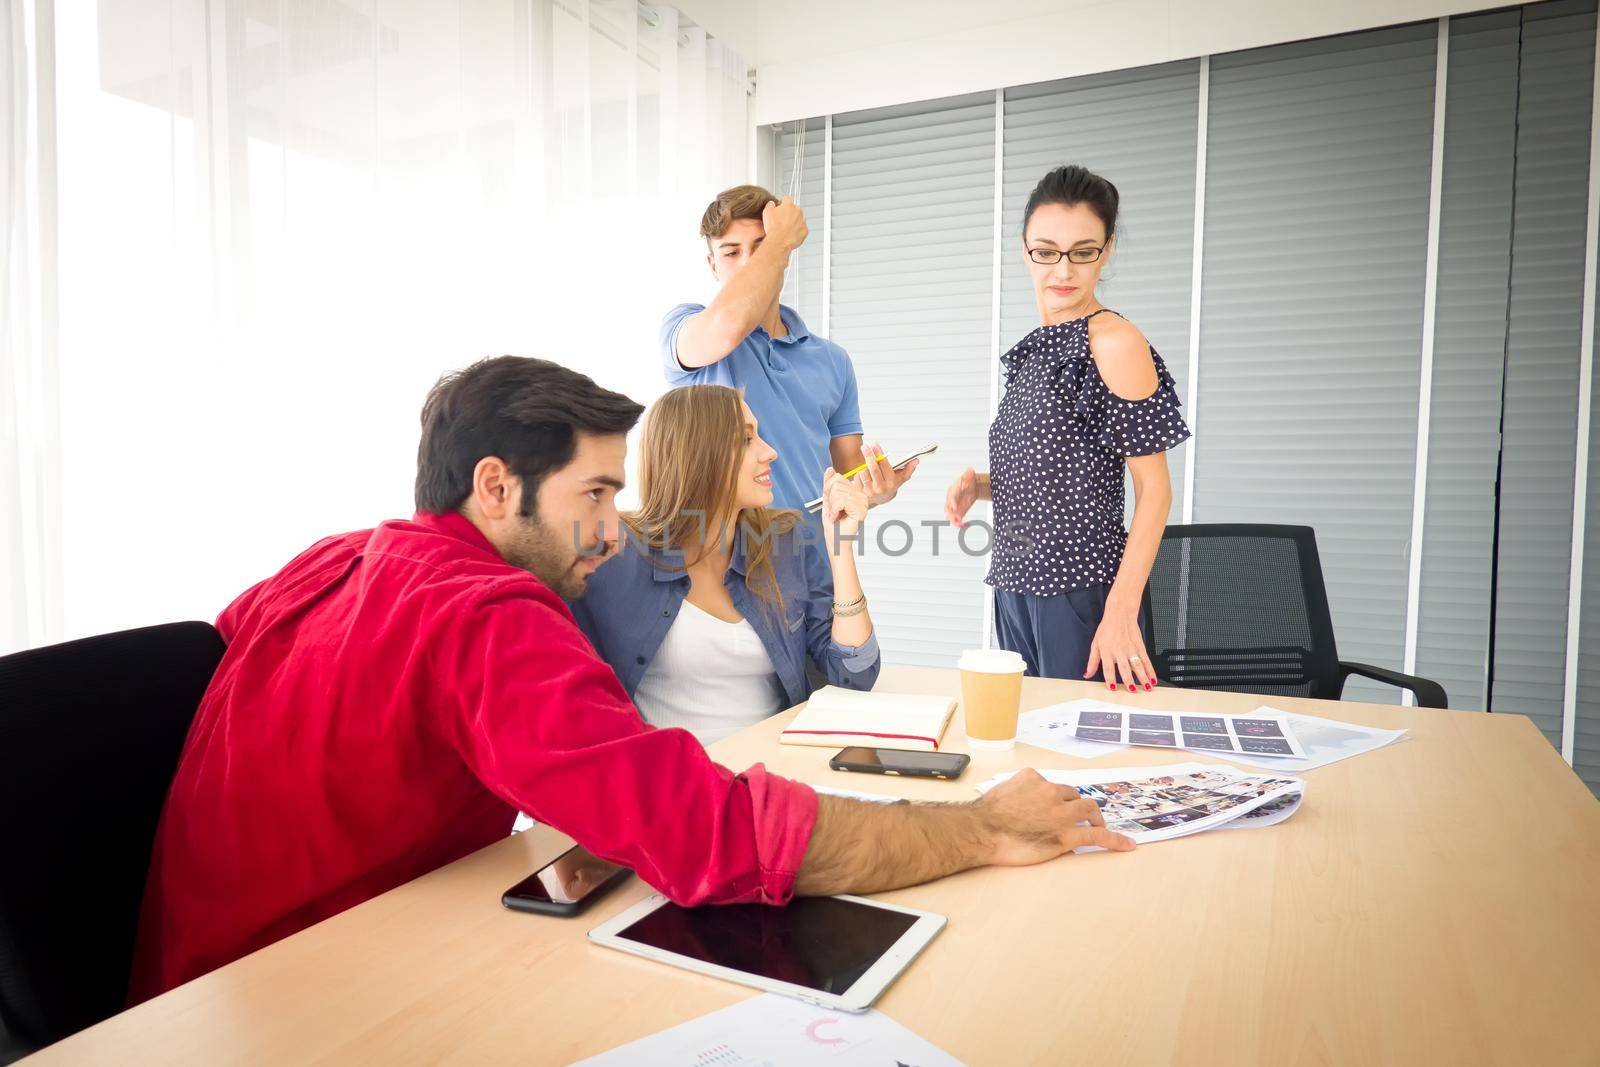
[{"left": 0, "top": 622, "right": 222, "bottom": 1062}]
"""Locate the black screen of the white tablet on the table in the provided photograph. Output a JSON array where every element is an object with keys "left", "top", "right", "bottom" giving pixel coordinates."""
[{"left": 618, "top": 896, "right": 917, "bottom": 993}]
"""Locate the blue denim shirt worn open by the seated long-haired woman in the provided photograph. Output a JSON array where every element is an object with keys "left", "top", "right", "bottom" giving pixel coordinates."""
[{"left": 568, "top": 526, "right": 880, "bottom": 707}]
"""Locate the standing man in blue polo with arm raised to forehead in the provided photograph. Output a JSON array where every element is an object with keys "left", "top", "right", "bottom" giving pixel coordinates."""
[{"left": 661, "top": 186, "right": 917, "bottom": 509}]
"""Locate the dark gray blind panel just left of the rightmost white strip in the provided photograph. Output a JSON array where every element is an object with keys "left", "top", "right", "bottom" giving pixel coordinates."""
[{"left": 1490, "top": 0, "right": 1595, "bottom": 744}]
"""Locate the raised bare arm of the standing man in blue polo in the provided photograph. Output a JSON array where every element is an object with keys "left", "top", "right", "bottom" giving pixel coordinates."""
[{"left": 675, "top": 197, "right": 806, "bottom": 370}]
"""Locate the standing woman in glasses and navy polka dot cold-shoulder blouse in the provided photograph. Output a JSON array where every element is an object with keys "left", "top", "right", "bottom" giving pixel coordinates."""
[{"left": 944, "top": 159, "right": 1189, "bottom": 691}]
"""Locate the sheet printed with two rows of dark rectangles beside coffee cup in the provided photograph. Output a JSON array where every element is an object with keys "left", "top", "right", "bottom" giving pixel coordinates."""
[{"left": 1072, "top": 701, "right": 1306, "bottom": 758}]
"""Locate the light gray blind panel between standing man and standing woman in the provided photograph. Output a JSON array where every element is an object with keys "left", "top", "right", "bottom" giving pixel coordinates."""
[{"left": 830, "top": 93, "right": 995, "bottom": 665}]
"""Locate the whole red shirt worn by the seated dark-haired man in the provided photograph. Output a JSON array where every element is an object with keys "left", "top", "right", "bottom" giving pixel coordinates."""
[{"left": 131, "top": 515, "right": 816, "bottom": 1001}]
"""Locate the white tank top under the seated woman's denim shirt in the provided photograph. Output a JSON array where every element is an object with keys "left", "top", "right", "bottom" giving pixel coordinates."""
[{"left": 634, "top": 600, "right": 784, "bottom": 744}]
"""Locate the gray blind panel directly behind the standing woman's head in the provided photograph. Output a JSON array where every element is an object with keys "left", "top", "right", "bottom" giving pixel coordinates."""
[{"left": 1000, "top": 59, "right": 1200, "bottom": 508}]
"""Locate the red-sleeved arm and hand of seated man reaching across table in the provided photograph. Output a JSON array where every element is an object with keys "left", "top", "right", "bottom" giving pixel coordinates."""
[{"left": 437, "top": 587, "right": 1133, "bottom": 904}]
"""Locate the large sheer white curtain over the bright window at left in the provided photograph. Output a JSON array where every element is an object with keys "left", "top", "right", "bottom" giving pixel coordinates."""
[{"left": 0, "top": 0, "right": 750, "bottom": 651}]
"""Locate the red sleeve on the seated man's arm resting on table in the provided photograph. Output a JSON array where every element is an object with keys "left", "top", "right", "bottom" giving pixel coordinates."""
[{"left": 437, "top": 582, "right": 816, "bottom": 905}]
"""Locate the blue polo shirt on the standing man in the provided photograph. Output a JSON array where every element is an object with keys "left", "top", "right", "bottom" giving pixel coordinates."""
[{"left": 661, "top": 304, "right": 861, "bottom": 509}]
